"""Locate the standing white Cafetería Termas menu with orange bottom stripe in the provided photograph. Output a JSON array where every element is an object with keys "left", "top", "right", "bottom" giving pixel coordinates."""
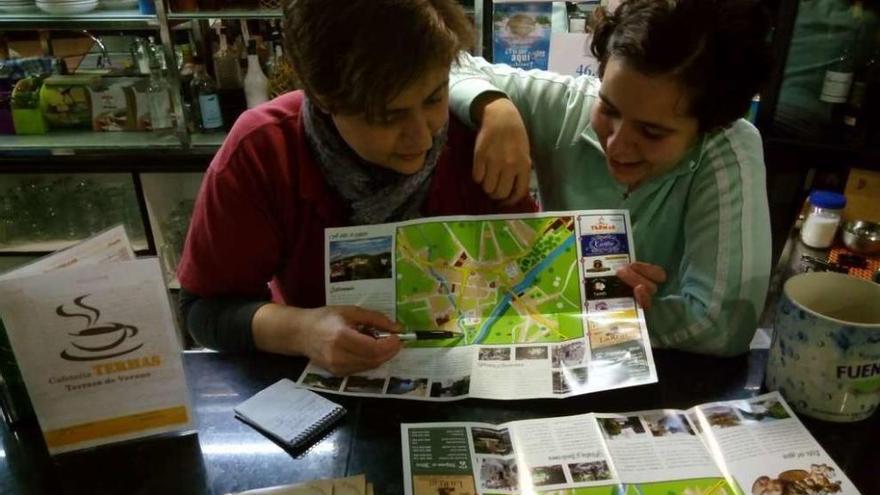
[{"left": 0, "top": 227, "right": 192, "bottom": 454}]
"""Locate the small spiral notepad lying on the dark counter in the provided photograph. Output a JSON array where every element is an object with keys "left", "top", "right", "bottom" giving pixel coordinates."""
[{"left": 234, "top": 378, "right": 346, "bottom": 448}]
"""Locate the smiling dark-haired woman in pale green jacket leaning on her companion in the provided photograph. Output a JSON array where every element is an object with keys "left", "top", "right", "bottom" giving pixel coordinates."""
[{"left": 450, "top": 0, "right": 771, "bottom": 355}]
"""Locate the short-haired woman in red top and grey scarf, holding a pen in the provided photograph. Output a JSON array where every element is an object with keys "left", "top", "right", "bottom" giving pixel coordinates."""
[{"left": 178, "top": 0, "right": 535, "bottom": 375}]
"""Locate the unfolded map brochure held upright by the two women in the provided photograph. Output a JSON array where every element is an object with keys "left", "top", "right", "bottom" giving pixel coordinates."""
[{"left": 299, "top": 210, "right": 657, "bottom": 401}]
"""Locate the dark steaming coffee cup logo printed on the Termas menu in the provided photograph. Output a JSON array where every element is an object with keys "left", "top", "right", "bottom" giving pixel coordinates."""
[{"left": 55, "top": 294, "right": 144, "bottom": 361}]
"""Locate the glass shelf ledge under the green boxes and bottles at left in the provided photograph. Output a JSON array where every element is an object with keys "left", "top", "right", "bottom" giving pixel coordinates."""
[{"left": 0, "top": 130, "right": 182, "bottom": 155}]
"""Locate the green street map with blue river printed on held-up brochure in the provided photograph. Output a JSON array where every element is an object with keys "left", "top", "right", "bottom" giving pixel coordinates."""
[{"left": 395, "top": 217, "right": 584, "bottom": 346}]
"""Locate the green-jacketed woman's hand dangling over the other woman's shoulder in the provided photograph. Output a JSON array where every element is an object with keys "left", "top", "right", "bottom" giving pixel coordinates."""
[{"left": 471, "top": 93, "right": 532, "bottom": 205}]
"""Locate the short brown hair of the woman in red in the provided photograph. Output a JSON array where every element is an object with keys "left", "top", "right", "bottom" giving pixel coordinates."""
[{"left": 284, "top": 0, "right": 474, "bottom": 121}]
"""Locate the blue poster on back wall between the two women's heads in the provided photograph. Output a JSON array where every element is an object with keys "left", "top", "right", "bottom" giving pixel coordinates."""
[{"left": 492, "top": 2, "right": 553, "bottom": 70}]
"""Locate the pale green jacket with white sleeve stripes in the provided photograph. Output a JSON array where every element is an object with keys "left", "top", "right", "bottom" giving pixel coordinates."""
[{"left": 450, "top": 55, "right": 772, "bottom": 356}]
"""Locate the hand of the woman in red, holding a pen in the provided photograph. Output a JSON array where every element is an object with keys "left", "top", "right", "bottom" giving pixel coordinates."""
[{"left": 253, "top": 304, "right": 401, "bottom": 376}]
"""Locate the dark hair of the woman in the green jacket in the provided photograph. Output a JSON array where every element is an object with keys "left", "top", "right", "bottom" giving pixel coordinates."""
[{"left": 591, "top": 0, "right": 771, "bottom": 131}]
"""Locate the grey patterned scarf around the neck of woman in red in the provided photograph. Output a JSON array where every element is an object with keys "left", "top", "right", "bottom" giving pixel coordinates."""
[{"left": 303, "top": 98, "right": 447, "bottom": 225}]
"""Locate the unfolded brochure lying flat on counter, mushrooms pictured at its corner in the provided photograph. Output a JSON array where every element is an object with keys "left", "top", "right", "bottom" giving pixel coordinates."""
[{"left": 401, "top": 392, "right": 859, "bottom": 495}]
